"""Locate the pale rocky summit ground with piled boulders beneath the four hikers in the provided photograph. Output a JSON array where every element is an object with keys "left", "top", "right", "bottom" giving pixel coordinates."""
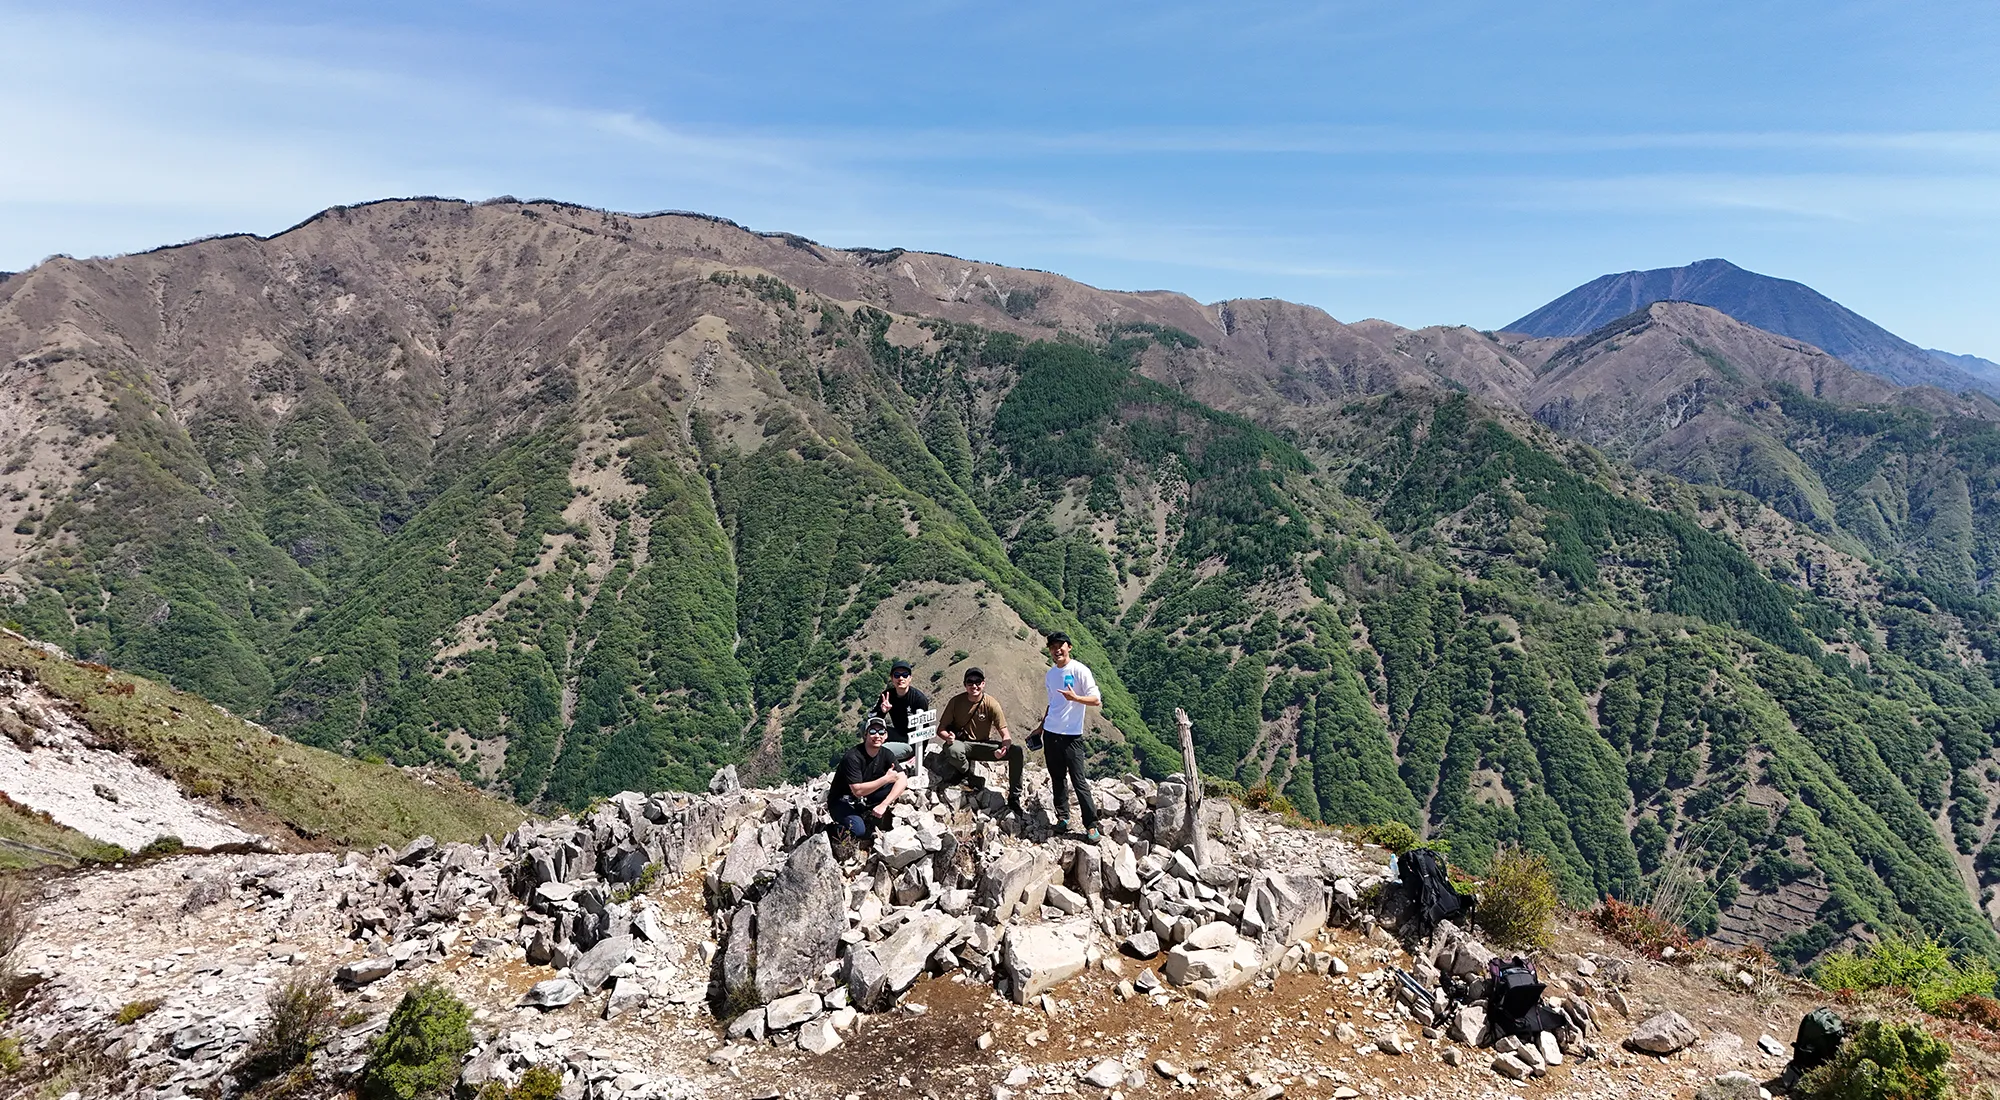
[{"left": 0, "top": 770, "right": 1872, "bottom": 1100}]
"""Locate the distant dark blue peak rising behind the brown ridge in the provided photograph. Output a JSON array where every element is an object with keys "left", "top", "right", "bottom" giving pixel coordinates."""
[{"left": 1506, "top": 258, "right": 2000, "bottom": 394}]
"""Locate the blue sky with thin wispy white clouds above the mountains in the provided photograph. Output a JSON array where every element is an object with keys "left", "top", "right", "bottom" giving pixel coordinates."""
[{"left": 11, "top": 0, "right": 2000, "bottom": 360}]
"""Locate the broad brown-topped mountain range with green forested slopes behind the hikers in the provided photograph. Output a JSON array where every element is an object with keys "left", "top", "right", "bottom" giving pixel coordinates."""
[{"left": 0, "top": 200, "right": 2000, "bottom": 958}]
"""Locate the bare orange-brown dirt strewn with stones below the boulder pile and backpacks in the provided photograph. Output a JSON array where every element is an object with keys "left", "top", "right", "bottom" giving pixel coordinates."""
[{"left": 712, "top": 924, "right": 2000, "bottom": 1100}]
